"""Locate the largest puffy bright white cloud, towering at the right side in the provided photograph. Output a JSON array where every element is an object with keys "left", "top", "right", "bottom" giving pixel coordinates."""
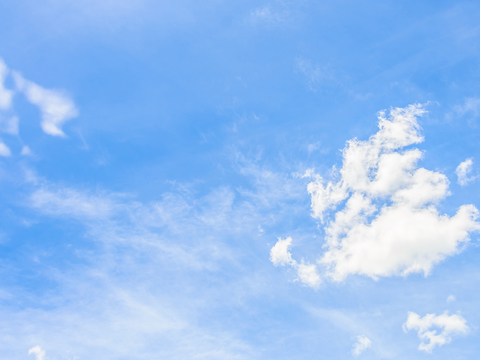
[{"left": 271, "top": 104, "right": 480, "bottom": 281}]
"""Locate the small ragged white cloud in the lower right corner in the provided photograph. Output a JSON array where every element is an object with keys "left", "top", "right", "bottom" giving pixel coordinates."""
[{"left": 403, "top": 311, "right": 469, "bottom": 353}]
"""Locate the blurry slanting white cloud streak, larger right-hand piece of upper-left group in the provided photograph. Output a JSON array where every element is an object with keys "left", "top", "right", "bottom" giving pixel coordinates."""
[{"left": 13, "top": 72, "right": 78, "bottom": 136}]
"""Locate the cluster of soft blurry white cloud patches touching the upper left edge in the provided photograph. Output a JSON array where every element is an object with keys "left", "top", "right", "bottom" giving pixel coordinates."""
[{"left": 0, "top": 58, "right": 78, "bottom": 150}]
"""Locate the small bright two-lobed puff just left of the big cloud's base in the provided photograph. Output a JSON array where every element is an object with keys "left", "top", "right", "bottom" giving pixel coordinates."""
[{"left": 270, "top": 237, "right": 321, "bottom": 288}]
